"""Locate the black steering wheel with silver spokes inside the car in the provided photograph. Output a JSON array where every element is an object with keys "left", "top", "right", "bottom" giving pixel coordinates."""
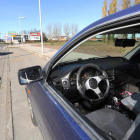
[{"left": 76, "top": 63, "right": 109, "bottom": 103}]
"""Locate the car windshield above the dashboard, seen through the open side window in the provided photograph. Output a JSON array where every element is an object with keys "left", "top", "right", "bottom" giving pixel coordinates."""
[{"left": 59, "top": 34, "right": 140, "bottom": 63}]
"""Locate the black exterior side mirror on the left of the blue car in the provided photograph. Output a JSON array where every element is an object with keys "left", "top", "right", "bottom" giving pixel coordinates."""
[{"left": 18, "top": 66, "right": 43, "bottom": 85}]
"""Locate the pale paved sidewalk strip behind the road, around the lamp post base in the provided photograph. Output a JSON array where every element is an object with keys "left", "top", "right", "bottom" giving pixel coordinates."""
[{"left": 8, "top": 44, "right": 58, "bottom": 60}]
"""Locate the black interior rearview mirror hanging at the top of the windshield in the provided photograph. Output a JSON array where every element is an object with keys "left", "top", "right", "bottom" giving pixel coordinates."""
[{"left": 115, "top": 39, "right": 136, "bottom": 48}]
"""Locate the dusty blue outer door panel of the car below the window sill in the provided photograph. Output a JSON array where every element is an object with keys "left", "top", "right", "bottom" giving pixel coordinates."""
[{"left": 30, "top": 82, "right": 91, "bottom": 140}]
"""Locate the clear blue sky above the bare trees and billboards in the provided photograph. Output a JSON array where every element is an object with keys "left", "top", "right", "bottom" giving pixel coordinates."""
[{"left": 0, "top": 0, "right": 104, "bottom": 38}]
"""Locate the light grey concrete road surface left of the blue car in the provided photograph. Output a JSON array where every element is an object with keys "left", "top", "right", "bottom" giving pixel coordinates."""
[{"left": 0, "top": 45, "right": 47, "bottom": 140}]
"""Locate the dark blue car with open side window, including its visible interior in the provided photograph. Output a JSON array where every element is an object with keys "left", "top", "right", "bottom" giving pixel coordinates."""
[{"left": 18, "top": 4, "right": 140, "bottom": 140}]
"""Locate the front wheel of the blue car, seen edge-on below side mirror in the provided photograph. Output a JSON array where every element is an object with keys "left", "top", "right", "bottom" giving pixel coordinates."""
[{"left": 27, "top": 95, "right": 38, "bottom": 126}]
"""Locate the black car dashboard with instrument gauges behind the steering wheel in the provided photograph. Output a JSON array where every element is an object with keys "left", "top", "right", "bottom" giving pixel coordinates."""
[{"left": 50, "top": 57, "right": 138, "bottom": 100}]
